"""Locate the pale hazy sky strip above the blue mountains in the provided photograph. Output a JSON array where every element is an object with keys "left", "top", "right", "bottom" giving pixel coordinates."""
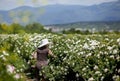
[{"left": 0, "top": 0, "right": 118, "bottom": 10}]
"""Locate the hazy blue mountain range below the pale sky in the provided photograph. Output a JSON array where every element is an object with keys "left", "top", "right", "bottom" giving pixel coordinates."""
[{"left": 0, "top": 1, "right": 120, "bottom": 25}]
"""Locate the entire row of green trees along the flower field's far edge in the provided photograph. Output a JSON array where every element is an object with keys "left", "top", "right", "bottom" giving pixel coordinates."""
[{"left": 0, "top": 23, "right": 120, "bottom": 35}]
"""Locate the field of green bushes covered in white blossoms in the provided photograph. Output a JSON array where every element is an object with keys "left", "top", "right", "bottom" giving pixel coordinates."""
[{"left": 0, "top": 34, "right": 120, "bottom": 81}]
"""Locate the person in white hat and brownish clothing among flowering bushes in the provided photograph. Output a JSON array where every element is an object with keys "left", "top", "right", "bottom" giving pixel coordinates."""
[{"left": 35, "top": 39, "right": 56, "bottom": 81}]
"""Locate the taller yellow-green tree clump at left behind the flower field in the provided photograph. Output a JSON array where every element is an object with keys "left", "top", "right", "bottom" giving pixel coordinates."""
[{"left": 0, "top": 23, "right": 50, "bottom": 34}]
